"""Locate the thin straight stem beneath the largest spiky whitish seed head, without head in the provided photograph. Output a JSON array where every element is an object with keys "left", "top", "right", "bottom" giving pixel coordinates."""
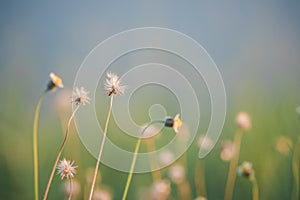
[{"left": 89, "top": 96, "right": 113, "bottom": 200}]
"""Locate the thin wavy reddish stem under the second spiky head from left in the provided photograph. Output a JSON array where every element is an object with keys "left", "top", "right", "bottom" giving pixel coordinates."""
[{"left": 43, "top": 106, "right": 79, "bottom": 200}]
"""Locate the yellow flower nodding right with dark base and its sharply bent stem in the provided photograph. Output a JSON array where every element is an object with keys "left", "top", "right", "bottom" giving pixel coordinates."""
[{"left": 122, "top": 114, "right": 182, "bottom": 200}]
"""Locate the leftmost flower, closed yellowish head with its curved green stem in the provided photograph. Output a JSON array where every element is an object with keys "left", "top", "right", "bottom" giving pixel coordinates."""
[{"left": 32, "top": 73, "right": 63, "bottom": 200}]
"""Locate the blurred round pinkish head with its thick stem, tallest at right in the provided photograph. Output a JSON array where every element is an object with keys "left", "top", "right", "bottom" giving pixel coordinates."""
[{"left": 225, "top": 112, "right": 252, "bottom": 200}]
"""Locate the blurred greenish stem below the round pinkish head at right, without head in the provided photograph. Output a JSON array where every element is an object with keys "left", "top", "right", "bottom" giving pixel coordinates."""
[{"left": 225, "top": 129, "right": 243, "bottom": 200}]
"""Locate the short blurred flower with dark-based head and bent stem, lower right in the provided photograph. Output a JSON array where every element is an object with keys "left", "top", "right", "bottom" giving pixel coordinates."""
[{"left": 237, "top": 161, "right": 259, "bottom": 200}]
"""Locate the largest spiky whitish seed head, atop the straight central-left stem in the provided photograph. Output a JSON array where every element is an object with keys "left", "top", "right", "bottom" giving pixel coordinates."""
[{"left": 104, "top": 72, "right": 125, "bottom": 96}]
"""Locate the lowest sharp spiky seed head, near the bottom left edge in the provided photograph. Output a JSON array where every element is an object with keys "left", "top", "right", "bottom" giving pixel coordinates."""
[{"left": 56, "top": 158, "right": 78, "bottom": 179}]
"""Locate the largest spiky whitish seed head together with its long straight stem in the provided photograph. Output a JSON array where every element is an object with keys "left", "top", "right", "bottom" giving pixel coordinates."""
[{"left": 89, "top": 73, "right": 125, "bottom": 200}]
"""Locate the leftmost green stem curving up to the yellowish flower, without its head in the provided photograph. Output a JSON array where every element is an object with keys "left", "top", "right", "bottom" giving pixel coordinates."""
[{"left": 33, "top": 91, "right": 46, "bottom": 200}]
